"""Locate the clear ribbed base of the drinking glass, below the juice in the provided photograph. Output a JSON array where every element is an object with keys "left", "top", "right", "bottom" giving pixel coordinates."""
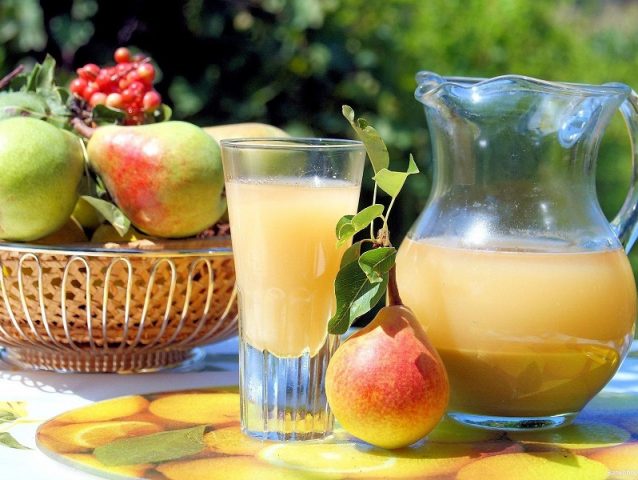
[{"left": 239, "top": 335, "right": 339, "bottom": 440}]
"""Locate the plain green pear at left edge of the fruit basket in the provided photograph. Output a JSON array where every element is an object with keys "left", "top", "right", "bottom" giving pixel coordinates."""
[{"left": 0, "top": 117, "right": 84, "bottom": 241}]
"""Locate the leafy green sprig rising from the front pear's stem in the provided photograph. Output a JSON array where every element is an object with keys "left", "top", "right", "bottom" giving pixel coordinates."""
[{"left": 328, "top": 105, "right": 419, "bottom": 334}]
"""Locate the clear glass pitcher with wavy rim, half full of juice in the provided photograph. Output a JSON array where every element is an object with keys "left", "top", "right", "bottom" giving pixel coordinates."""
[{"left": 397, "top": 72, "right": 638, "bottom": 430}]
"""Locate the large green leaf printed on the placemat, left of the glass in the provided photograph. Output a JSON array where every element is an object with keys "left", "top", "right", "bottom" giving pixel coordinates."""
[{"left": 93, "top": 425, "right": 206, "bottom": 467}]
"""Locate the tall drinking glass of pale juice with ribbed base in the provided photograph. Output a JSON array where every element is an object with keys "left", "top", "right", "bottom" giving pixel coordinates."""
[{"left": 221, "top": 138, "right": 365, "bottom": 440}]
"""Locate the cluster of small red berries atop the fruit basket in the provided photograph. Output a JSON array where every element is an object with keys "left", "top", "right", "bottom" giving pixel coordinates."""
[{"left": 69, "top": 47, "right": 162, "bottom": 124}]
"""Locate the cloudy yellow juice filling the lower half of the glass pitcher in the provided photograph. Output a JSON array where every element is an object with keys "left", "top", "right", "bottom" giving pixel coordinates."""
[{"left": 397, "top": 238, "right": 636, "bottom": 416}]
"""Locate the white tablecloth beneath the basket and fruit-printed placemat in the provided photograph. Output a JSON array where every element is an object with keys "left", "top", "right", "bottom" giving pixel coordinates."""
[{"left": 0, "top": 337, "right": 638, "bottom": 480}]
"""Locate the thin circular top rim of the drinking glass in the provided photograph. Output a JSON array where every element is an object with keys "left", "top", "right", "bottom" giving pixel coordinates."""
[{"left": 219, "top": 137, "right": 365, "bottom": 151}]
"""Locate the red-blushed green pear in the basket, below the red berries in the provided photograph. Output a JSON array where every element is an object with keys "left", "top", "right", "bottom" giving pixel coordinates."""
[{"left": 87, "top": 121, "right": 225, "bottom": 238}]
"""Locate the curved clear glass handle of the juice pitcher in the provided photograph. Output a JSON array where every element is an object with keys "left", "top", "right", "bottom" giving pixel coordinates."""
[{"left": 611, "top": 90, "right": 638, "bottom": 253}]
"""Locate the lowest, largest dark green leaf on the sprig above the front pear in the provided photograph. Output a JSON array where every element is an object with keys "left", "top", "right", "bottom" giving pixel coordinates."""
[{"left": 328, "top": 262, "right": 388, "bottom": 335}]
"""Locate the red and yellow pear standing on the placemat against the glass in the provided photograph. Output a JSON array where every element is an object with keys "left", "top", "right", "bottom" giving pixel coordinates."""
[{"left": 326, "top": 305, "right": 449, "bottom": 448}]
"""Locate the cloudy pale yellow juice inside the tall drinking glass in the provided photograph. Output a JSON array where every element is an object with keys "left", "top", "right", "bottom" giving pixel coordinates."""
[{"left": 226, "top": 179, "right": 359, "bottom": 357}]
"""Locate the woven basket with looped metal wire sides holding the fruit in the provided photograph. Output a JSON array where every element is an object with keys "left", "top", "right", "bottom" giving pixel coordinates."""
[{"left": 0, "top": 236, "right": 237, "bottom": 372}]
